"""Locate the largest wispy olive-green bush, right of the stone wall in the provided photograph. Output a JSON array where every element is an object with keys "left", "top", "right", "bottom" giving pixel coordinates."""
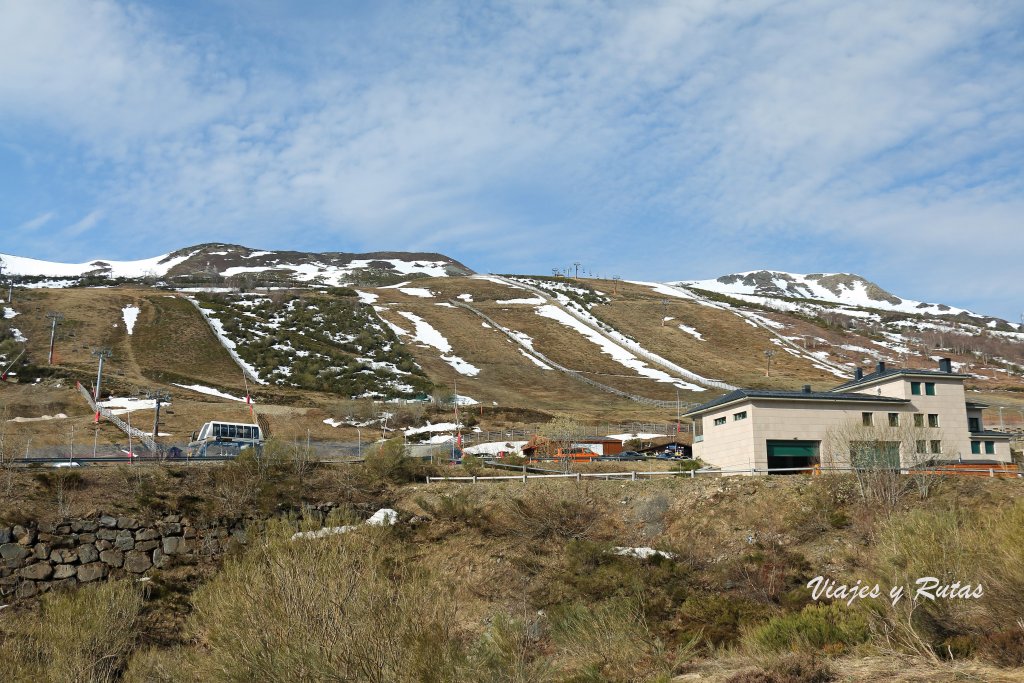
[{"left": 193, "top": 522, "right": 464, "bottom": 683}]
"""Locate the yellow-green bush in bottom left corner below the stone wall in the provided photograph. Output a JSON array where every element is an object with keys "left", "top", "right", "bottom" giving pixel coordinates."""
[{"left": 0, "top": 582, "right": 142, "bottom": 683}]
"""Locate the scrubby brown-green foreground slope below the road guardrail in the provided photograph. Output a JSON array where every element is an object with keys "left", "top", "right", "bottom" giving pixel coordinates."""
[{"left": 0, "top": 458, "right": 1024, "bottom": 683}]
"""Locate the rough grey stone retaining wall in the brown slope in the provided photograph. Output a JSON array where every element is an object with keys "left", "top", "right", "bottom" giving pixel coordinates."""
[{"left": 0, "top": 514, "right": 252, "bottom": 599}]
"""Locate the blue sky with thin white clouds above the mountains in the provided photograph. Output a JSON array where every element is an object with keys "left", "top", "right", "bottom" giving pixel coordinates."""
[{"left": 0, "top": 0, "right": 1024, "bottom": 319}]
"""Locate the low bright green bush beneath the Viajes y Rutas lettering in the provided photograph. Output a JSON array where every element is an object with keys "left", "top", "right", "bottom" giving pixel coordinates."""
[{"left": 744, "top": 603, "right": 870, "bottom": 653}]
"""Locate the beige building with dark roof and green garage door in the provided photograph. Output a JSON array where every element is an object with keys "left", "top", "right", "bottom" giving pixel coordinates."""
[{"left": 687, "top": 359, "right": 1012, "bottom": 474}]
